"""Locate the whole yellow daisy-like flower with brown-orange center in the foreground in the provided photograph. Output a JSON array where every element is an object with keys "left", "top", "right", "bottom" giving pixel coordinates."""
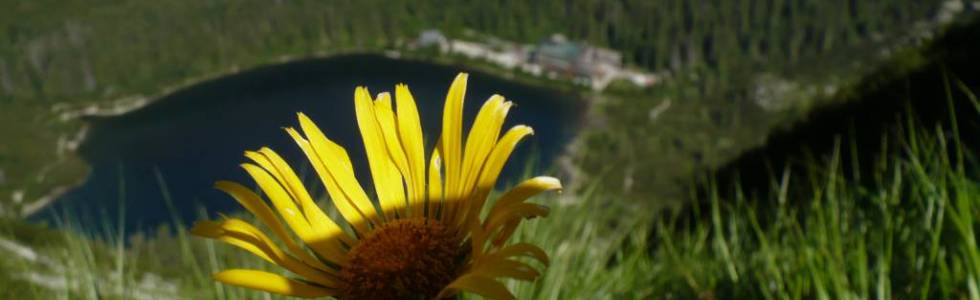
[{"left": 191, "top": 74, "right": 561, "bottom": 299}]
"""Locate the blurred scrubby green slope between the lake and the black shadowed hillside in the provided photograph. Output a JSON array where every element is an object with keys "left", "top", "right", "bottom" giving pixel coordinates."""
[{"left": 571, "top": 12, "right": 977, "bottom": 205}]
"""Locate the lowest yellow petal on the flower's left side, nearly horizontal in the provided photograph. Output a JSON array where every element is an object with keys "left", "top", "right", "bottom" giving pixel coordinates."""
[{"left": 214, "top": 269, "right": 336, "bottom": 298}]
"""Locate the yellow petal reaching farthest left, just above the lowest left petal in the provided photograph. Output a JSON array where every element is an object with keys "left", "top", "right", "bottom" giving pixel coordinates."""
[{"left": 191, "top": 219, "right": 338, "bottom": 287}]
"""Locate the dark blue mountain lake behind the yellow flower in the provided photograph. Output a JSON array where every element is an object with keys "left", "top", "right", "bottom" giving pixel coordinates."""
[{"left": 35, "top": 55, "right": 582, "bottom": 232}]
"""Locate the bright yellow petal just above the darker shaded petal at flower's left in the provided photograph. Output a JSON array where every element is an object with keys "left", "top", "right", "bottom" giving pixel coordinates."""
[{"left": 242, "top": 164, "right": 344, "bottom": 261}]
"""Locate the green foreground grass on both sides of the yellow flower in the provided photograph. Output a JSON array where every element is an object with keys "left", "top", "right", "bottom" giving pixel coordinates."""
[{"left": 0, "top": 78, "right": 980, "bottom": 299}]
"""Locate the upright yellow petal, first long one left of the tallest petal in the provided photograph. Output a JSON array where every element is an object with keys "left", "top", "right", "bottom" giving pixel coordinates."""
[{"left": 395, "top": 84, "right": 425, "bottom": 216}]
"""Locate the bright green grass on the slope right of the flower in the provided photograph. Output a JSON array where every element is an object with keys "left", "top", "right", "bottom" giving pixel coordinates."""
[{"left": 519, "top": 96, "right": 980, "bottom": 299}]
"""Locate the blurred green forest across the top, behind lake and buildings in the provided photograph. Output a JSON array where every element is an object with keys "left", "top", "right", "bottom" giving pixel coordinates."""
[{"left": 0, "top": 0, "right": 936, "bottom": 102}]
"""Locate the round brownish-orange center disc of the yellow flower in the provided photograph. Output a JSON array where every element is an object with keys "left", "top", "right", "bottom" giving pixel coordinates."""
[{"left": 340, "top": 218, "right": 460, "bottom": 299}]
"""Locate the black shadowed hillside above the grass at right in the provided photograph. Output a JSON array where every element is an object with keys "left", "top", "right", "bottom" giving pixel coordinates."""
[{"left": 712, "top": 18, "right": 980, "bottom": 199}]
